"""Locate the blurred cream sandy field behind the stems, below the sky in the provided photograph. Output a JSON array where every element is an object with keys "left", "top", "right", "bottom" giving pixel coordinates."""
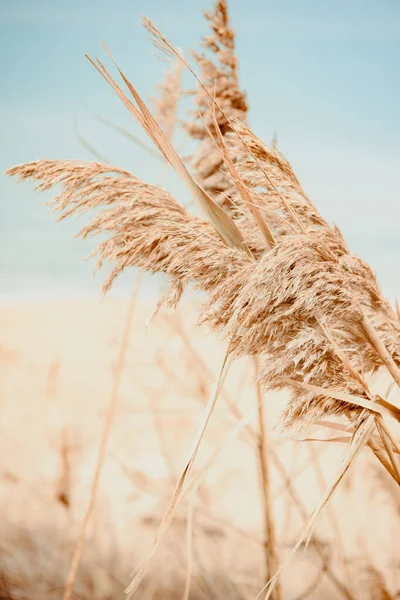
[{"left": 0, "top": 298, "right": 400, "bottom": 600}]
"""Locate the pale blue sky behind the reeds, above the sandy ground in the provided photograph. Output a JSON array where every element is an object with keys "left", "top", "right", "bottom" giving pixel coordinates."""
[{"left": 0, "top": 0, "right": 400, "bottom": 300}]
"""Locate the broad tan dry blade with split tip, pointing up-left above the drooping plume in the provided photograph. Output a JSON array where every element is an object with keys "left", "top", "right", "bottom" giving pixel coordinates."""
[{"left": 88, "top": 49, "right": 251, "bottom": 256}]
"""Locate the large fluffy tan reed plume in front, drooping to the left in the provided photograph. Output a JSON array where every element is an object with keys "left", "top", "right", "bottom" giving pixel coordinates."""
[{"left": 8, "top": 144, "right": 400, "bottom": 432}]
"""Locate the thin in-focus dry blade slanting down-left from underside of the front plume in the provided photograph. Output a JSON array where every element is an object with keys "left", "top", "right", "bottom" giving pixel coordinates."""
[{"left": 126, "top": 353, "right": 231, "bottom": 598}]
